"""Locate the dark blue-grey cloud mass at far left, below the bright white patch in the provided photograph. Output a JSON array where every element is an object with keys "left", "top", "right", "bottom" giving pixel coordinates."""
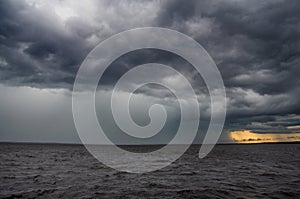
[{"left": 0, "top": 1, "right": 91, "bottom": 87}]
